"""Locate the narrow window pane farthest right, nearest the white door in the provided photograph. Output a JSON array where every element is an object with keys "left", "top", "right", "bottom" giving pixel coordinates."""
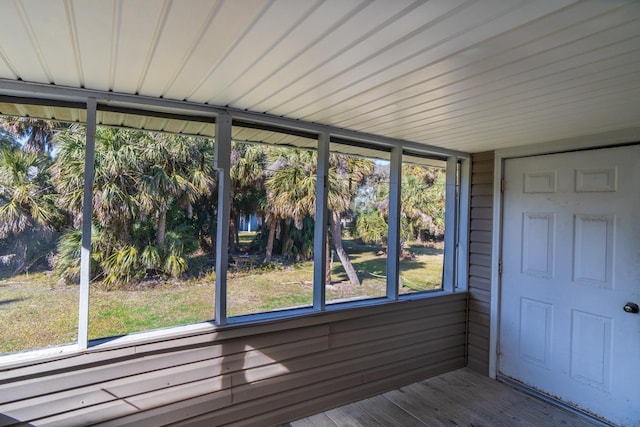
[{"left": 400, "top": 156, "right": 446, "bottom": 294}]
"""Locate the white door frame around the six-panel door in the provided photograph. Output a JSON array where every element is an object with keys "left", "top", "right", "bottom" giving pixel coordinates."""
[{"left": 489, "top": 127, "right": 640, "bottom": 379}]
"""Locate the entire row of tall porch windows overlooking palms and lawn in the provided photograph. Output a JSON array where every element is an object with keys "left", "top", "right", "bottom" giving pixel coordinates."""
[{"left": 0, "top": 103, "right": 468, "bottom": 353}]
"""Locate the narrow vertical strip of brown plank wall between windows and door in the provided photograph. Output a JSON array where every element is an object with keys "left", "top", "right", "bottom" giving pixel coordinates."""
[{"left": 467, "top": 151, "right": 494, "bottom": 375}]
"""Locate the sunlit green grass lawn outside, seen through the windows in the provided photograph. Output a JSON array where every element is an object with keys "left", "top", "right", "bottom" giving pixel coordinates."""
[{"left": 0, "top": 236, "right": 443, "bottom": 353}]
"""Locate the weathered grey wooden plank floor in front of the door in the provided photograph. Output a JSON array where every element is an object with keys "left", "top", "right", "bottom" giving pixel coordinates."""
[{"left": 283, "top": 369, "right": 600, "bottom": 427}]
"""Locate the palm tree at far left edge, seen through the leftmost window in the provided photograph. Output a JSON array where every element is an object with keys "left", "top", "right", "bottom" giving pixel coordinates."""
[{"left": 0, "top": 144, "right": 62, "bottom": 274}]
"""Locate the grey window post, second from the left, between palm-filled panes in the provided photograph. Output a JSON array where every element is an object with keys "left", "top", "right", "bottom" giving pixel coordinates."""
[{"left": 214, "top": 113, "right": 231, "bottom": 325}]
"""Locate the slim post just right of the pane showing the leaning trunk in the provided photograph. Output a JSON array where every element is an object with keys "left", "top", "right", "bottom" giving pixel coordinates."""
[{"left": 387, "top": 146, "right": 402, "bottom": 300}]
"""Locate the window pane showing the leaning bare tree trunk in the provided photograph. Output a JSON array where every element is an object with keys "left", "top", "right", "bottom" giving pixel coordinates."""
[{"left": 326, "top": 150, "right": 389, "bottom": 303}]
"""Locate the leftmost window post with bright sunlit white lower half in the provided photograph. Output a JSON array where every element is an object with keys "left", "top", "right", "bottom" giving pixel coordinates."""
[{"left": 78, "top": 98, "right": 97, "bottom": 349}]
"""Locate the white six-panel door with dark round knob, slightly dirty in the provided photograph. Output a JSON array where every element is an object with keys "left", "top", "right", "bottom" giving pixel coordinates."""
[{"left": 499, "top": 145, "right": 640, "bottom": 426}]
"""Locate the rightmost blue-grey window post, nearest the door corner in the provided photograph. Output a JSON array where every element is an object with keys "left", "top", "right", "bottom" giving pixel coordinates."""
[{"left": 442, "top": 156, "right": 458, "bottom": 292}]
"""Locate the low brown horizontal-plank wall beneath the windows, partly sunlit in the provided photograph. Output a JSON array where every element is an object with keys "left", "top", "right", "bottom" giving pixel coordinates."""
[{"left": 0, "top": 293, "right": 468, "bottom": 426}]
